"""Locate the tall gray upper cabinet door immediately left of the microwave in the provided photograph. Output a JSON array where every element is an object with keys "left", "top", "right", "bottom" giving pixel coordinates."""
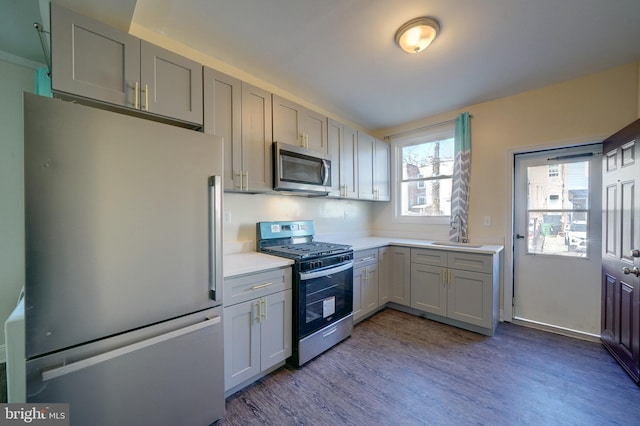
[{"left": 242, "top": 82, "right": 273, "bottom": 192}]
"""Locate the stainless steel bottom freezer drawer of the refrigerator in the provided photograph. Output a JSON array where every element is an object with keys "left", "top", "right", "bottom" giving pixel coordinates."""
[{"left": 27, "top": 308, "right": 224, "bottom": 425}]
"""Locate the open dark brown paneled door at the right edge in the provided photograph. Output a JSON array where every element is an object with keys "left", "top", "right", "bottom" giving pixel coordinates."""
[{"left": 601, "top": 120, "right": 640, "bottom": 382}]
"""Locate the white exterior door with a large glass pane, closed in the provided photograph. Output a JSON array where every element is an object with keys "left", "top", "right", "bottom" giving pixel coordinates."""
[{"left": 513, "top": 145, "right": 601, "bottom": 338}]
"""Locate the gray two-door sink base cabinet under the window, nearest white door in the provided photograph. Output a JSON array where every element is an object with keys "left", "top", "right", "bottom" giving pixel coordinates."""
[{"left": 411, "top": 248, "right": 499, "bottom": 335}]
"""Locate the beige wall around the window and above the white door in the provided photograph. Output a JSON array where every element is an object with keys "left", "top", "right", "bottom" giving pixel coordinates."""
[{"left": 372, "top": 61, "right": 640, "bottom": 244}]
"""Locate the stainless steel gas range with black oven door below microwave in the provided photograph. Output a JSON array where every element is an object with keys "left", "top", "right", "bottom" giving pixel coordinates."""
[{"left": 256, "top": 220, "right": 353, "bottom": 366}]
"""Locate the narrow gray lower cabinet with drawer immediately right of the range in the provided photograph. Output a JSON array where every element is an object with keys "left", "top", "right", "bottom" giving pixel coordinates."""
[{"left": 353, "top": 248, "right": 380, "bottom": 322}]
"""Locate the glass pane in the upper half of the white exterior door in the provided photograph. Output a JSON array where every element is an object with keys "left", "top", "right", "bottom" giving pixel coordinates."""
[{"left": 527, "top": 161, "right": 589, "bottom": 257}]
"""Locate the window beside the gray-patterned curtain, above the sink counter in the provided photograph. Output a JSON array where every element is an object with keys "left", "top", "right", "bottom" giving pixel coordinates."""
[{"left": 392, "top": 126, "right": 454, "bottom": 223}]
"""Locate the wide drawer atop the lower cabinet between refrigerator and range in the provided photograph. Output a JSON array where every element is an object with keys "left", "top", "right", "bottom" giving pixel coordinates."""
[{"left": 224, "top": 268, "right": 292, "bottom": 306}]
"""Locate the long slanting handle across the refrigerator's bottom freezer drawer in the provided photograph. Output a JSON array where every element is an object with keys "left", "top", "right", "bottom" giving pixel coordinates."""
[{"left": 42, "top": 316, "right": 221, "bottom": 382}]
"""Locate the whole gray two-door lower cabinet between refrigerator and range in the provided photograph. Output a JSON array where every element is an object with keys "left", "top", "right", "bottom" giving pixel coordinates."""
[{"left": 223, "top": 268, "right": 292, "bottom": 395}]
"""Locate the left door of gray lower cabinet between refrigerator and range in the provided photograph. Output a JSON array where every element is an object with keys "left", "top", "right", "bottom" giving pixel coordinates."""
[{"left": 222, "top": 299, "right": 260, "bottom": 391}]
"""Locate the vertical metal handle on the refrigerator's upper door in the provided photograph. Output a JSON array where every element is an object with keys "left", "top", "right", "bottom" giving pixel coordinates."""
[{"left": 209, "top": 176, "right": 223, "bottom": 304}]
